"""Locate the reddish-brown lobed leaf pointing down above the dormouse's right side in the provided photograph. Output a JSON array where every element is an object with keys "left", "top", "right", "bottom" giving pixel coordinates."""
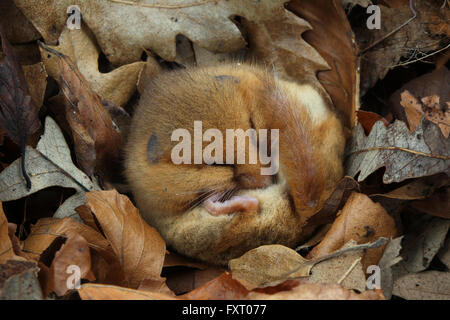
[{"left": 287, "top": 0, "right": 359, "bottom": 128}]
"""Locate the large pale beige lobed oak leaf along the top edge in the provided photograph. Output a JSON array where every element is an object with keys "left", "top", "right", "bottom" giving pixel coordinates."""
[{"left": 15, "top": 0, "right": 287, "bottom": 64}]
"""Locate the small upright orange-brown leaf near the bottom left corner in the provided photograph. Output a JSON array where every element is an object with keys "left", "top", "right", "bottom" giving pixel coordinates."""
[{"left": 45, "top": 232, "right": 94, "bottom": 296}]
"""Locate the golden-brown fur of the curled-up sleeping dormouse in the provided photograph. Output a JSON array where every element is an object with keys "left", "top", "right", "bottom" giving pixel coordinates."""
[{"left": 126, "top": 64, "right": 345, "bottom": 264}]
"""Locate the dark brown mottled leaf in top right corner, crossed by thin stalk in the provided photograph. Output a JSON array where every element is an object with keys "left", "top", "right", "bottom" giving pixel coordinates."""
[{"left": 355, "top": 0, "right": 450, "bottom": 95}]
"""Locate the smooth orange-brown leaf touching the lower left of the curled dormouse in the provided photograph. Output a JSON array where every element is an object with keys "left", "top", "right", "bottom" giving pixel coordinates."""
[{"left": 80, "top": 190, "right": 166, "bottom": 288}]
